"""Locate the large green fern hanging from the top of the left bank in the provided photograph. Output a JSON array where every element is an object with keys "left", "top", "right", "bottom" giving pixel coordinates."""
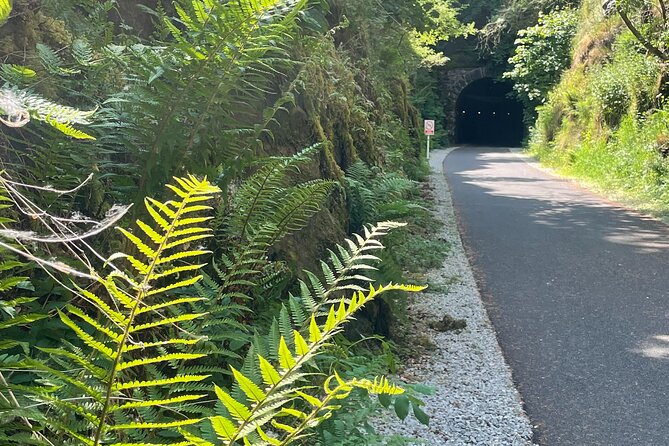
[{"left": 109, "top": 0, "right": 307, "bottom": 199}]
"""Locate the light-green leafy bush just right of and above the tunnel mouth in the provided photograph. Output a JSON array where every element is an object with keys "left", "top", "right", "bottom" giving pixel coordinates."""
[{"left": 504, "top": 9, "right": 578, "bottom": 105}]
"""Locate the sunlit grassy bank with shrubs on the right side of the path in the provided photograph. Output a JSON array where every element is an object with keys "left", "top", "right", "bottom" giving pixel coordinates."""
[{"left": 515, "top": 0, "right": 669, "bottom": 215}]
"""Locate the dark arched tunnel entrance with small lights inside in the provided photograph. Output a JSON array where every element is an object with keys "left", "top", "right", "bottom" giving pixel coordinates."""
[{"left": 455, "top": 78, "right": 525, "bottom": 147}]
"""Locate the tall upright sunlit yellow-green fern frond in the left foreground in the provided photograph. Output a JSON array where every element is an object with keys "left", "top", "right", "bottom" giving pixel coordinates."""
[{"left": 3, "top": 176, "right": 219, "bottom": 445}]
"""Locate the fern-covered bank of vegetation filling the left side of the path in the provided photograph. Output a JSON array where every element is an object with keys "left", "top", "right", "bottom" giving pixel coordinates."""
[{"left": 0, "top": 0, "right": 472, "bottom": 446}]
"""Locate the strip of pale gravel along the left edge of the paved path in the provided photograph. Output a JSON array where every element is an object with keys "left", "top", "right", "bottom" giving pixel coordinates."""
[{"left": 374, "top": 149, "right": 532, "bottom": 446}]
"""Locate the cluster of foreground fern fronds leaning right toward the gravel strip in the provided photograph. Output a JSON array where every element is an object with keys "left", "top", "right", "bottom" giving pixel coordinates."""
[{"left": 180, "top": 222, "right": 423, "bottom": 445}]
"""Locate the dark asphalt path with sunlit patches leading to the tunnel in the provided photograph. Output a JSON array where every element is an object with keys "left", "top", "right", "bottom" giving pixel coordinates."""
[{"left": 444, "top": 147, "right": 669, "bottom": 446}]
